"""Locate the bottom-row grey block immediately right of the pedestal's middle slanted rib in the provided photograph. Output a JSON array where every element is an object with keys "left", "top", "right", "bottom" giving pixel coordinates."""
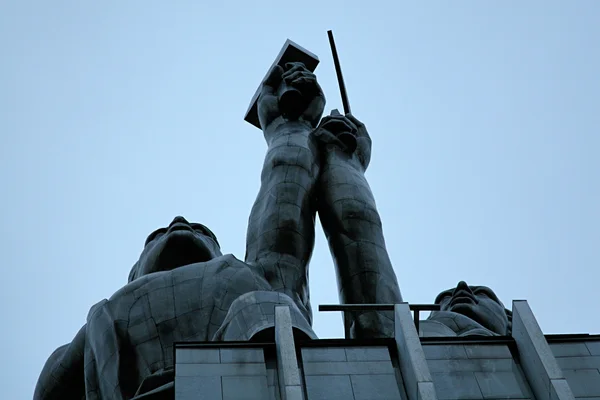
[{"left": 431, "top": 372, "right": 483, "bottom": 400}]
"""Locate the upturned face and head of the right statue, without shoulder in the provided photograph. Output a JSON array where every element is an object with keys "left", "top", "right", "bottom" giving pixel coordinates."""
[{"left": 435, "top": 281, "right": 509, "bottom": 335}]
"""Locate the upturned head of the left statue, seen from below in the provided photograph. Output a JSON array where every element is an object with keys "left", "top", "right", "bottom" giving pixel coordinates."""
[{"left": 129, "top": 217, "right": 222, "bottom": 282}]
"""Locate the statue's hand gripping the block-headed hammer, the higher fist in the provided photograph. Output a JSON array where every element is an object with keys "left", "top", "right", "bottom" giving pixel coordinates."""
[{"left": 258, "top": 62, "right": 325, "bottom": 136}]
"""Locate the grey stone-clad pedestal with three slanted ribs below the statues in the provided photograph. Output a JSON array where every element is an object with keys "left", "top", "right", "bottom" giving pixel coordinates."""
[{"left": 175, "top": 301, "right": 600, "bottom": 400}]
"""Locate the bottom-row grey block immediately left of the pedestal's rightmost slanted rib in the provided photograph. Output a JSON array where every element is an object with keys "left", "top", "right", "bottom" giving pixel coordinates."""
[{"left": 475, "top": 371, "right": 532, "bottom": 399}]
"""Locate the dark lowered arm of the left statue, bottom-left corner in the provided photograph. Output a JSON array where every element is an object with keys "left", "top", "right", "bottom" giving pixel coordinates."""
[{"left": 33, "top": 325, "right": 85, "bottom": 400}]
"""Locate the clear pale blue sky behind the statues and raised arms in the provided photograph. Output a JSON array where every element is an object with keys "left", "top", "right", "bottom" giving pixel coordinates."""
[{"left": 0, "top": 0, "right": 600, "bottom": 399}]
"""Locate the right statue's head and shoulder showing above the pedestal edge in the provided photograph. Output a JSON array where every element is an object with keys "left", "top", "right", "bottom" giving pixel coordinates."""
[{"left": 419, "top": 281, "right": 512, "bottom": 337}]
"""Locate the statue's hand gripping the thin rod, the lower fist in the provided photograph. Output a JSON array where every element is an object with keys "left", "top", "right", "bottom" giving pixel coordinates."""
[{"left": 314, "top": 111, "right": 371, "bottom": 171}]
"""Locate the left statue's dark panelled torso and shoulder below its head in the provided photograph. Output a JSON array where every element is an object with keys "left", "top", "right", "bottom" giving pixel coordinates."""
[{"left": 85, "top": 255, "right": 270, "bottom": 393}]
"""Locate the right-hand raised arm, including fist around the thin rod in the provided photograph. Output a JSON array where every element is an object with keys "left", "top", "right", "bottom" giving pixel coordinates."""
[{"left": 315, "top": 114, "right": 402, "bottom": 338}]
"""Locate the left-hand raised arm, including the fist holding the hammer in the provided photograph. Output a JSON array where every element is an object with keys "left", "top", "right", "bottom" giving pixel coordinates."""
[{"left": 246, "top": 63, "right": 325, "bottom": 322}]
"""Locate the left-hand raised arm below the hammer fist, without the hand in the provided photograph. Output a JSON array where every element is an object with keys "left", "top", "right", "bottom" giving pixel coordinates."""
[{"left": 246, "top": 122, "right": 320, "bottom": 322}]
